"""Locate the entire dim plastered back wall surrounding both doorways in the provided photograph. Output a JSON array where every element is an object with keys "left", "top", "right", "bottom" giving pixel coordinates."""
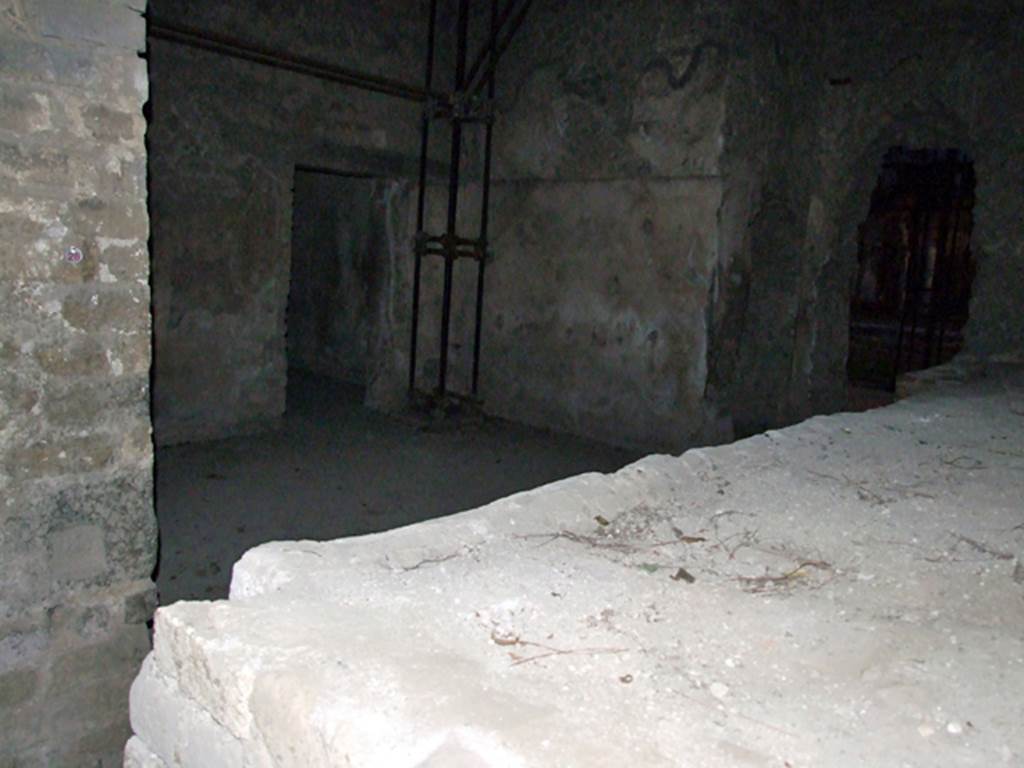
[{"left": 153, "top": 0, "right": 1022, "bottom": 450}]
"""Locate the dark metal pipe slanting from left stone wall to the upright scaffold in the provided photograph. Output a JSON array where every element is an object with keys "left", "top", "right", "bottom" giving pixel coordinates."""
[{"left": 147, "top": 18, "right": 450, "bottom": 103}]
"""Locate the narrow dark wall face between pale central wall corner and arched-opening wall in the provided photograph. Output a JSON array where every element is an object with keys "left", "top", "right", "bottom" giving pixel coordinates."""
[{"left": 708, "top": 1, "right": 823, "bottom": 434}]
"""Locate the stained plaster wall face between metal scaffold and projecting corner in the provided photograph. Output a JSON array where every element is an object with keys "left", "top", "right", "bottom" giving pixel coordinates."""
[{"left": 450, "top": 0, "right": 731, "bottom": 449}]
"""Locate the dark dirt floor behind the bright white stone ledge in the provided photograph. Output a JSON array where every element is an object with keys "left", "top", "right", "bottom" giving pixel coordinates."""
[{"left": 157, "top": 371, "right": 638, "bottom": 605}]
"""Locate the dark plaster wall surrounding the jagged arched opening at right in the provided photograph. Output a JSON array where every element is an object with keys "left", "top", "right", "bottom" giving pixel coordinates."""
[{"left": 795, "top": 0, "right": 1024, "bottom": 411}]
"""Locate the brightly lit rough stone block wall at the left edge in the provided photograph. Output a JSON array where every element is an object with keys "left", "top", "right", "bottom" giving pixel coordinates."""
[{"left": 0, "top": 0, "right": 157, "bottom": 768}]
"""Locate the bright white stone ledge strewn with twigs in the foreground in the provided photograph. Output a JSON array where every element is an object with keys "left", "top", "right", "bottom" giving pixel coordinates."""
[{"left": 126, "top": 370, "right": 1024, "bottom": 768}]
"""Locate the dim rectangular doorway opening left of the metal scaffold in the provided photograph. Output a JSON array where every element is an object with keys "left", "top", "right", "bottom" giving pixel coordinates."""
[{"left": 286, "top": 166, "right": 387, "bottom": 399}]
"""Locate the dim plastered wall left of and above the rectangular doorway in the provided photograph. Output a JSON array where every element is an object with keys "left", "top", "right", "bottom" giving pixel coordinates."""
[{"left": 150, "top": 0, "right": 422, "bottom": 442}]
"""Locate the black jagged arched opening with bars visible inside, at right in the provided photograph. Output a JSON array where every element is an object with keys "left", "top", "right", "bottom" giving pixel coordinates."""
[{"left": 847, "top": 146, "right": 975, "bottom": 391}]
